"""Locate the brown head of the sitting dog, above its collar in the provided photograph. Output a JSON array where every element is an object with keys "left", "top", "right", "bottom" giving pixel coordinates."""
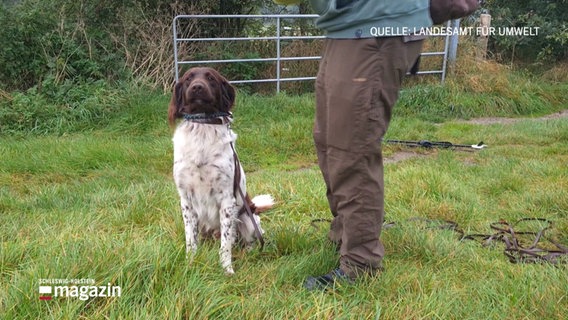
[{"left": 168, "top": 68, "right": 235, "bottom": 126}]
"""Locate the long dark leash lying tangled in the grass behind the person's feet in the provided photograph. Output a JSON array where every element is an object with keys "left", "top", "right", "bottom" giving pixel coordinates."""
[{"left": 311, "top": 217, "right": 568, "bottom": 265}]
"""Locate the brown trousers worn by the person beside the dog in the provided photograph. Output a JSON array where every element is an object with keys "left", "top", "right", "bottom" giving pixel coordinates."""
[{"left": 313, "top": 37, "right": 422, "bottom": 277}]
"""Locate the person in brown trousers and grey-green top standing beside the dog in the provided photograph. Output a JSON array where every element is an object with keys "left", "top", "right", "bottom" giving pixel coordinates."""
[{"left": 298, "top": 0, "right": 432, "bottom": 290}]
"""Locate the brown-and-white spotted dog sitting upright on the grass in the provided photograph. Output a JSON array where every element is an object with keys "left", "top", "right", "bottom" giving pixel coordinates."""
[{"left": 168, "top": 67, "right": 274, "bottom": 275}]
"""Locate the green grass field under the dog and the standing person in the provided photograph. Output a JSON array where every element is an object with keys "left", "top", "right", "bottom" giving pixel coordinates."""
[{"left": 0, "top": 64, "right": 568, "bottom": 319}]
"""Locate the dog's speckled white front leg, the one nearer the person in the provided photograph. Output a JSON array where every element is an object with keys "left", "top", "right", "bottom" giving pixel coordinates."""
[{"left": 219, "top": 196, "right": 237, "bottom": 275}]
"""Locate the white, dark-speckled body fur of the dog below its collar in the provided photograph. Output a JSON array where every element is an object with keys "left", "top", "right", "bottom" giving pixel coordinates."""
[{"left": 173, "top": 121, "right": 273, "bottom": 275}]
